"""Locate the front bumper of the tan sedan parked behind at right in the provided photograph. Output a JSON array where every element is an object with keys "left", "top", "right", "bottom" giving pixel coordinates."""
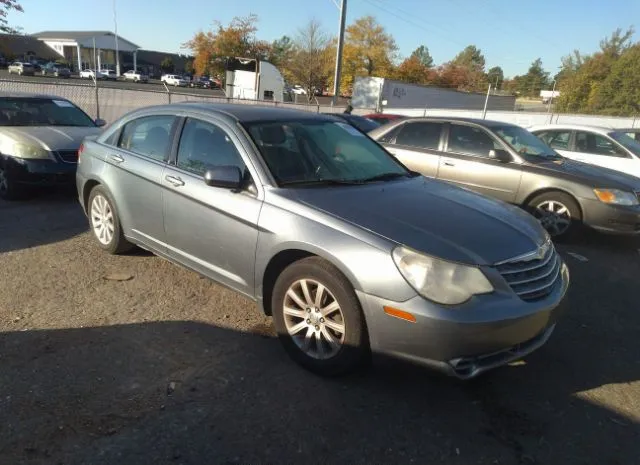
[{"left": 581, "top": 199, "right": 640, "bottom": 236}]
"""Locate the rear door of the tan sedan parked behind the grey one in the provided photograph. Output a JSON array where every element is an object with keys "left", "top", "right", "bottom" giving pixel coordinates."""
[{"left": 380, "top": 121, "right": 444, "bottom": 178}]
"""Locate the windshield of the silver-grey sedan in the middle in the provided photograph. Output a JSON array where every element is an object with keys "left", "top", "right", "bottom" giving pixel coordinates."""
[{"left": 245, "top": 120, "right": 414, "bottom": 186}]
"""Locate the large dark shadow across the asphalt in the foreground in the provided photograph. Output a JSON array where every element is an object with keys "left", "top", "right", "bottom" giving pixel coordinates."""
[{"left": 0, "top": 320, "right": 640, "bottom": 465}]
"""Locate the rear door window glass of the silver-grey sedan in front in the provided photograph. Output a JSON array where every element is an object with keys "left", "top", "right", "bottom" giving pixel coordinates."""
[{"left": 118, "top": 115, "right": 176, "bottom": 161}]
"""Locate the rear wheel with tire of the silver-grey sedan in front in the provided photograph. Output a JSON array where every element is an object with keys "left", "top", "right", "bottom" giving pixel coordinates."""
[{"left": 87, "top": 186, "right": 133, "bottom": 255}]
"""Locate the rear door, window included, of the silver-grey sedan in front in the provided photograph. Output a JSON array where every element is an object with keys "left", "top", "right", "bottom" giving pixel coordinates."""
[{"left": 105, "top": 115, "right": 178, "bottom": 251}]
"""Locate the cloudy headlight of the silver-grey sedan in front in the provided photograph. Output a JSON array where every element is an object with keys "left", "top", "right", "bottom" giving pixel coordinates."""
[{"left": 393, "top": 247, "right": 493, "bottom": 305}]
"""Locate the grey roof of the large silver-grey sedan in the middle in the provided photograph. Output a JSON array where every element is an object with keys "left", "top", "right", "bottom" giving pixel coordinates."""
[{"left": 169, "top": 102, "right": 334, "bottom": 123}]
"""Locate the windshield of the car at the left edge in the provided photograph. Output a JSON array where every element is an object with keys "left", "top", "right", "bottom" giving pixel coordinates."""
[{"left": 0, "top": 97, "right": 95, "bottom": 127}]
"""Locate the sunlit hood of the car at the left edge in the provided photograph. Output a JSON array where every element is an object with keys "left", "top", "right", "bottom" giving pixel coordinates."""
[{"left": 0, "top": 126, "right": 101, "bottom": 151}]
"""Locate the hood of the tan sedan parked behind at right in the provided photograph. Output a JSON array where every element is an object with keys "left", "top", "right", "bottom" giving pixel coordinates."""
[{"left": 529, "top": 158, "right": 640, "bottom": 190}]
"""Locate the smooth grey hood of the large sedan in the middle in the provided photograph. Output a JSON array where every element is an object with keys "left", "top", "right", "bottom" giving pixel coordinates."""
[{"left": 284, "top": 177, "right": 547, "bottom": 265}]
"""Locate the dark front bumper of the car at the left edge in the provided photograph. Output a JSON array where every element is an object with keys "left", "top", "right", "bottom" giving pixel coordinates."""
[{"left": 2, "top": 156, "right": 77, "bottom": 186}]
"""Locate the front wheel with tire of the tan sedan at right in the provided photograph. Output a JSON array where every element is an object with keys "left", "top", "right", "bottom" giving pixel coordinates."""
[{"left": 527, "top": 192, "right": 582, "bottom": 239}]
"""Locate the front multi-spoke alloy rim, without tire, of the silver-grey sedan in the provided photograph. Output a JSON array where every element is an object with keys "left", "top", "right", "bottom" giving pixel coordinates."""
[{"left": 282, "top": 279, "right": 346, "bottom": 360}]
